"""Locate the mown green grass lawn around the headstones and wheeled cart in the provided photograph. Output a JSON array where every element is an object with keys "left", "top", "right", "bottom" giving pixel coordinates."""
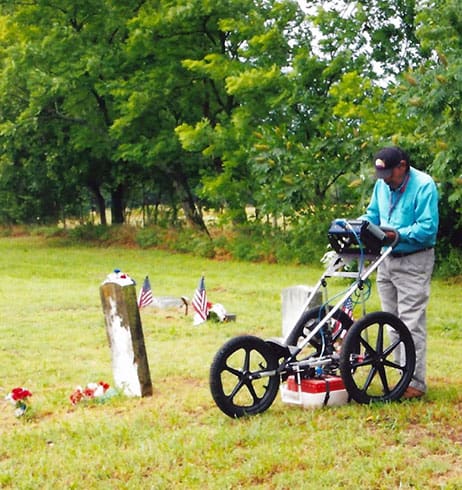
[{"left": 0, "top": 237, "right": 462, "bottom": 489}]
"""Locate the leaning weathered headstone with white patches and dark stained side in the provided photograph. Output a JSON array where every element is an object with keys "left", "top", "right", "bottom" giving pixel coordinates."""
[{"left": 100, "top": 271, "right": 152, "bottom": 397}]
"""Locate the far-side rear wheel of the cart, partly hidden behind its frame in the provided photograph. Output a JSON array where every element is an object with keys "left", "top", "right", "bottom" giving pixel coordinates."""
[{"left": 286, "top": 306, "right": 353, "bottom": 355}]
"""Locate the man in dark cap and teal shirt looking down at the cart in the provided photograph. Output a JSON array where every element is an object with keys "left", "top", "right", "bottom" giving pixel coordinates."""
[{"left": 361, "top": 147, "right": 438, "bottom": 398}]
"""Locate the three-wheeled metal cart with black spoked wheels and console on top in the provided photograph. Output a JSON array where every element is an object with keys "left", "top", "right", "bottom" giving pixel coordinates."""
[{"left": 210, "top": 219, "right": 415, "bottom": 418}]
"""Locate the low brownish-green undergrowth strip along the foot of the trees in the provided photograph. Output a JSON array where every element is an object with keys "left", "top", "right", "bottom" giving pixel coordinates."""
[{"left": 0, "top": 223, "right": 462, "bottom": 280}]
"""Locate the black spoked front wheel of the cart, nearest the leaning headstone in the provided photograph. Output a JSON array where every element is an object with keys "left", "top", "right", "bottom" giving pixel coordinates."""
[{"left": 210, "top": 335, "right": 279, "bottom": 418}]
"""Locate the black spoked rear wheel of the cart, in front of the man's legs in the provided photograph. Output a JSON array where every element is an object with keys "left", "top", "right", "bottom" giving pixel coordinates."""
[{"left": 340, "top": 311, "right": 415, "bottom": 403}]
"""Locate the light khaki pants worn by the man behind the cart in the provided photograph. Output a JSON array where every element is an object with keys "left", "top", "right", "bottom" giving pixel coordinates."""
[{"left": 377, "top": 249, "right": 435, "bottom": 392}]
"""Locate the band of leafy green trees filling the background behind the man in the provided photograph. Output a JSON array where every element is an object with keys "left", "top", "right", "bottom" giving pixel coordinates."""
[{"left": 0, "top": 0, "right": 462, "bottom": 268}]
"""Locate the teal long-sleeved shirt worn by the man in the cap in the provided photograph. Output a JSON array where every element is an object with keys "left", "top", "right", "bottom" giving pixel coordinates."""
[{"left": 361, "top": 167, "right": 439, "bottom": 253}]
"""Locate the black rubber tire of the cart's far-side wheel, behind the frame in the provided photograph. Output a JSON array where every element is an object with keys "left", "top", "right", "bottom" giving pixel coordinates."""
[{"left": 286, "top": 306, "right": 353, "bottom": 355}]
